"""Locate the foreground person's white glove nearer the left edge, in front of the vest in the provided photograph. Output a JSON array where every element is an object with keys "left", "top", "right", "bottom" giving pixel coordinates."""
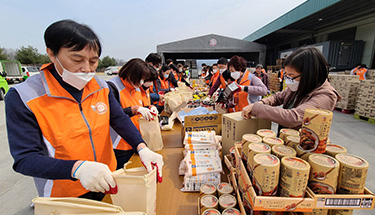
[{"left": 73, "top": 161, "right": 116, "bottom": 193}]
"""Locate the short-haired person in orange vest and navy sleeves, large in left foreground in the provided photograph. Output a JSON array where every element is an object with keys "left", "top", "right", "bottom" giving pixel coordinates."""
[{"left": 5, "top": 20, "right": 163, "bottom": 200}]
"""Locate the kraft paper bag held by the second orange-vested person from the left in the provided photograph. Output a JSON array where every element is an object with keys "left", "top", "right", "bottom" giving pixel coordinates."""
[{"left": 138, "top": 117, "right": 164, "bottom": 151}]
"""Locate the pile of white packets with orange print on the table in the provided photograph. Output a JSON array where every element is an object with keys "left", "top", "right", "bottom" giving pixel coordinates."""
[{"left": 179, "top": 131, "right": 222, "bottom": 192}]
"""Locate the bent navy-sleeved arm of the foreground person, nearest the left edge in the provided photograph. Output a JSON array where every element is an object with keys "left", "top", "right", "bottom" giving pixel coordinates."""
[{"left": 5, "top": 88, "right": 76, "bottom": 179}]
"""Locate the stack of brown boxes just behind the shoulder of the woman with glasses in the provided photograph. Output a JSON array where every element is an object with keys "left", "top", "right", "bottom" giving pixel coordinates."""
[{"left": 329, "top": 75, "right": 359, "bottom": 110}]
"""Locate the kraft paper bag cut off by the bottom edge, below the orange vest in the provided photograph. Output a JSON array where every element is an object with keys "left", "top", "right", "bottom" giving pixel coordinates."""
[{"left": 33, "top": 197, "right": 124, "bottom": 215}]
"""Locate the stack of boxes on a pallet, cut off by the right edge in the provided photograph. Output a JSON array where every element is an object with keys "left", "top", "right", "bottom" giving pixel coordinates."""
[{"left": 355, "top": 80, "right": 375, "bottom": 119}]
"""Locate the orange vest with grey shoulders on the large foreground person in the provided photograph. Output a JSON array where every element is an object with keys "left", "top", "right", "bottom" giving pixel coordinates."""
[{"left": 15, "top": 63, "right": 117, "bottom": 197}]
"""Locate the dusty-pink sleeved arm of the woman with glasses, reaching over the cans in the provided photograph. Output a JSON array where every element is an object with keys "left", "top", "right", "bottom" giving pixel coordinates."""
[{"left": 251, "top": 90, "right": 337, "bottom": 128}]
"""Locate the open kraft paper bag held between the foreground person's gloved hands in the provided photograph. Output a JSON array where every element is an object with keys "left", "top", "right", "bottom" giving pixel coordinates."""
[{"left": 111, "top": 163, "right": 156, "bottom": 215}]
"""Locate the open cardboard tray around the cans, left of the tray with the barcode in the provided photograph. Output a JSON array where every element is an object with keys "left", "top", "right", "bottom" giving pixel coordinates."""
[{"left": 231, "top": 147, "right": 316, "bottom": 212}]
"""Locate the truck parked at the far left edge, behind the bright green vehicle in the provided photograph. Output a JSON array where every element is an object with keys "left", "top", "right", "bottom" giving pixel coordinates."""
[{"left": 0, "top": 60, "right": 25, "bottom": 84}]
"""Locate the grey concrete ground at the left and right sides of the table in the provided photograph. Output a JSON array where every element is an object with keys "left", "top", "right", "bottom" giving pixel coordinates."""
[{"left": 0, "top": 74, "right": 375, "bottom": 215}]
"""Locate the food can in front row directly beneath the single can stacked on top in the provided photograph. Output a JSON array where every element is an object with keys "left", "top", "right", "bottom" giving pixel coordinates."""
[{"left": 309, "top": 154, "right": 340, "bottom": 194}]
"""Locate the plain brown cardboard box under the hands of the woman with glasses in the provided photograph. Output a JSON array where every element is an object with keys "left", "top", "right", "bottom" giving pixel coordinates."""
[{"left": 222, "top": 112, "right": 271, "bottom": 154}]
